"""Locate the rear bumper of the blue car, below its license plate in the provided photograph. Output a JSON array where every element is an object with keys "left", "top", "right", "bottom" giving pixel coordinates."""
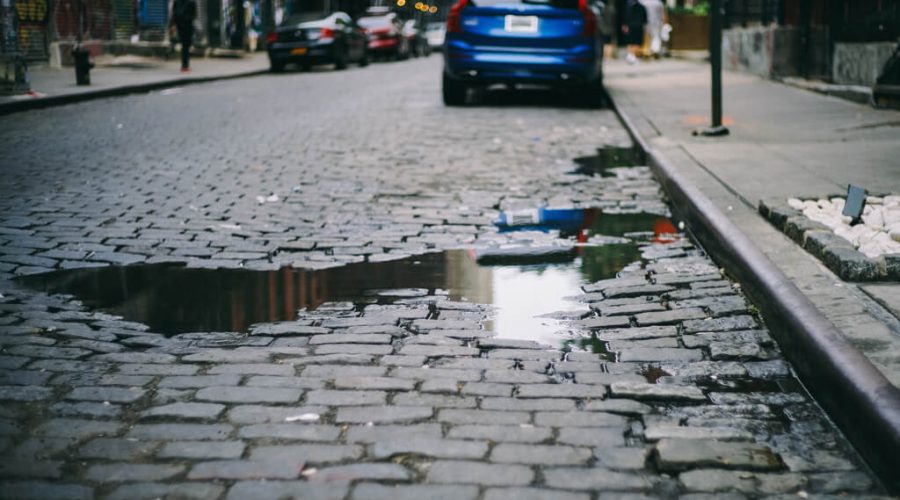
[{"left": 444, "top": 39, "right": 603, "bottom": 85}]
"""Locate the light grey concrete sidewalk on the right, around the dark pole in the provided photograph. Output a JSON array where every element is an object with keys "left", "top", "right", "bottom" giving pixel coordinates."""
[{"left": 606, "top": 56, "right": 900, "bottom": 482}]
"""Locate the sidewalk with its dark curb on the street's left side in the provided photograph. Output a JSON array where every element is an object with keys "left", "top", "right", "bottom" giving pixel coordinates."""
[{"left": 0, "top": 52, "right": 269, "bottom": 115}]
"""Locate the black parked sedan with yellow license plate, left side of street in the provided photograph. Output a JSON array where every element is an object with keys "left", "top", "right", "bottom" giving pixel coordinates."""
[{"left": 266, "top": 12, "right": 369, "bottom": 72}]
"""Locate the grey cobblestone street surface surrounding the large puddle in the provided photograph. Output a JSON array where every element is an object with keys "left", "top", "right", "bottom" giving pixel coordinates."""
[{"left": 0, "top": 57, "right": 887, "bottom": 500}]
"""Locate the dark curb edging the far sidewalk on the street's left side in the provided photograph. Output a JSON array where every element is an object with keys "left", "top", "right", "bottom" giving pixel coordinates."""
[{"left": 0, "top": 69, "right": 269, "bottom": 116}]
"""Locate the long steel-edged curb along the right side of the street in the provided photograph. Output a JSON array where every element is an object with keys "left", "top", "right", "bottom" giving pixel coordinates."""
[{"left": 610, "top": 93, "right": 900, "bottom": 494}]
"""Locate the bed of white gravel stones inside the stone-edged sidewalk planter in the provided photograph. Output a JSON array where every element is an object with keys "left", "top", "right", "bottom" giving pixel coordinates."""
[{"left": 788, "top": 196, "right": 900, "bottom": 258}]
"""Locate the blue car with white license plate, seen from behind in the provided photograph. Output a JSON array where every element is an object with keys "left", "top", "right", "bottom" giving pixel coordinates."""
[{"left": 443, "top": 0, "right": 603, "bottom": 106}]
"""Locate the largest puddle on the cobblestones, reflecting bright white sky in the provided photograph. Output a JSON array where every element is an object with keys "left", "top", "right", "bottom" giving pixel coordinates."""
[{"left": 17, "top": 214, "right": 674, "bottom": 349}]
